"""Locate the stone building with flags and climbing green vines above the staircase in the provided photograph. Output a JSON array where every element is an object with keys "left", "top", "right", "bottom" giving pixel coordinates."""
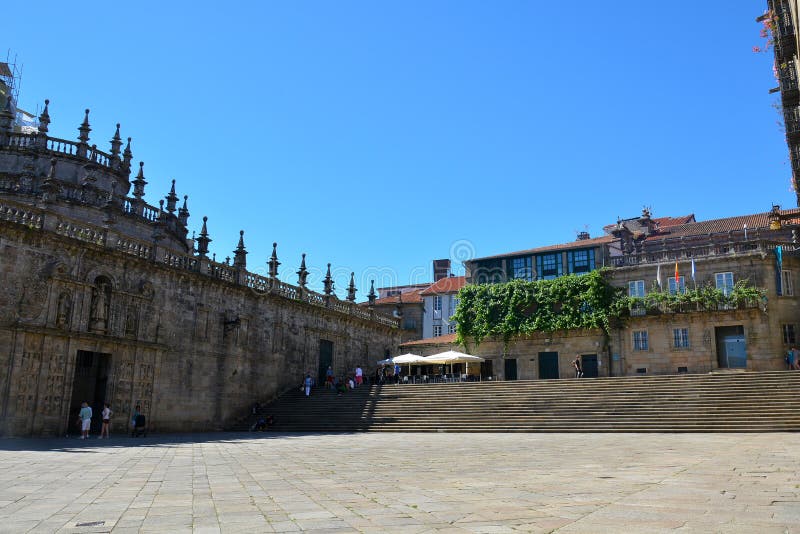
[{"left": 400, "top": 206, "right": 800, "bottom": 379}]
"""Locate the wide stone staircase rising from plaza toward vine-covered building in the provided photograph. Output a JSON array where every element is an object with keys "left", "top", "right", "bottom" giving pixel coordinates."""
[{"left": 232, "top": 371, "right": 800, "bottom": 432}]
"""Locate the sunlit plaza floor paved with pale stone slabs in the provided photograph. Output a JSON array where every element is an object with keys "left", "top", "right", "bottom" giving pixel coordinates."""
[{"left": 0, "top": 433, "right": 800, "bottom": 533}]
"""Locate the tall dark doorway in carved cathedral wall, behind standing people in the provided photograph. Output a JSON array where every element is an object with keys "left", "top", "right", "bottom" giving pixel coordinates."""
[{"left": 68, "top": 350, "right": 111, "bottom": 434}]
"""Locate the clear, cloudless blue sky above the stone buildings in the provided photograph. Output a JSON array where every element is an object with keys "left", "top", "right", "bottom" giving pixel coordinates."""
[{"left": 0, "top": 0, "right": 795, "bottom": 300}]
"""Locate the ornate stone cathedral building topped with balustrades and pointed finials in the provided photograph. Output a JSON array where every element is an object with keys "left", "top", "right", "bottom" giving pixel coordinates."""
[{"left": 0, "top": 98, "right": 400, "bottom": 436}]
